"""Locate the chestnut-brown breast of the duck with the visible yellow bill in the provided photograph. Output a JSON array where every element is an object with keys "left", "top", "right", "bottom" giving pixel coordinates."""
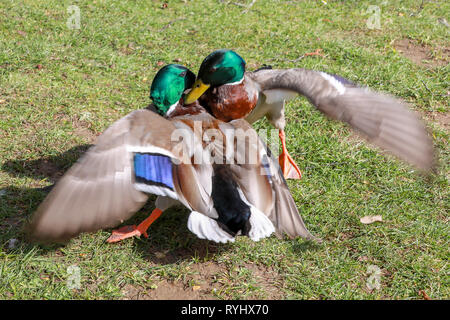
[{"left": 199, "top": 80, "right": 258, "bottom": 122}]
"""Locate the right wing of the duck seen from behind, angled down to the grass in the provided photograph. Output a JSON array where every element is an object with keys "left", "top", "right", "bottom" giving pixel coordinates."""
[{"left": 225, "top": 119, "right": 319, "bottom": 240}]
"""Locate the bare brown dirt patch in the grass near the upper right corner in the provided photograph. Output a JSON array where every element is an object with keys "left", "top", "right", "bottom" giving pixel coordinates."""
[{"left": 394, "top": 39, "right": 450, "bottom": 67}]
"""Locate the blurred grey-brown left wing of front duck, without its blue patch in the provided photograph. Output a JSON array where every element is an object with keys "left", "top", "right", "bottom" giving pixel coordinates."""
[{"left": 27, "top": 109, "right": 180, "bottom": 242}]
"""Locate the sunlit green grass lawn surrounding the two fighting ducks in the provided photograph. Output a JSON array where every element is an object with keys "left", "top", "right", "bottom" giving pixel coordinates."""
[{"left": 0, "top": 0, "right": 450, "bottom": 299}]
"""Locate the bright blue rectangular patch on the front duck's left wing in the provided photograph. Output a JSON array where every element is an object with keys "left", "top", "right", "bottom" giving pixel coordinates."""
[{"left": 134, "top": 153, "right": 173, "bottom": 190}]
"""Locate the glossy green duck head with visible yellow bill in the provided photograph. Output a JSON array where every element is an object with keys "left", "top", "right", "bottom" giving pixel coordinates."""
[{"left": 184, "top": 49, "right": 245, "bottom": 104}]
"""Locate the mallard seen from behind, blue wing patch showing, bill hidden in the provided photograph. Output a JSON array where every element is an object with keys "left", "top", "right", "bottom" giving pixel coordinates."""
[{"left": 28, "top": 64, "right": 315, "bottom": 243}]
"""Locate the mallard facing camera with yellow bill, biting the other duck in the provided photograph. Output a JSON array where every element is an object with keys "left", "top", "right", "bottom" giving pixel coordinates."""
[{"left": 185, "top": 50, "right": 433, "bottom": 179}]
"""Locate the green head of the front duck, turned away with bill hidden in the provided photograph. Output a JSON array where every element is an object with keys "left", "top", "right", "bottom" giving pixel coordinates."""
[{"left": 150, "top": 64, "right": 195, "bottom": 115}]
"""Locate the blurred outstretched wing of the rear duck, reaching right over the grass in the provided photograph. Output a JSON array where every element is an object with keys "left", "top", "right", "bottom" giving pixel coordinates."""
[{"left": 248, "top": 69, "right": 434, "bottom": 171}]
